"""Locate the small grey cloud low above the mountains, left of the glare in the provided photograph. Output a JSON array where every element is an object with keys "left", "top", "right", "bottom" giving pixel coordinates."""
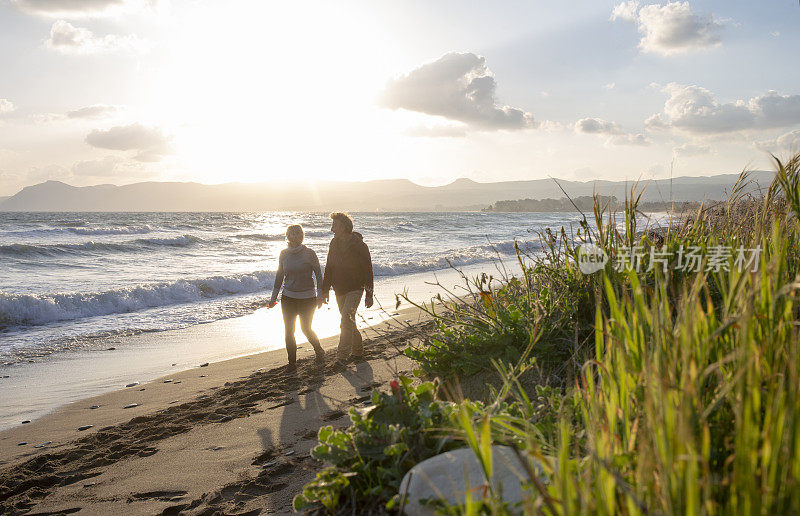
[{"left": 86, "top": 124, "right": 172, "bottom": 162}]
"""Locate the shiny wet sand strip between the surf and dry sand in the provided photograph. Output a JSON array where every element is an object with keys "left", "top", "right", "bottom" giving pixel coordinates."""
[{"left": 0, "top": 263, "right": 492, "bottom": 431}]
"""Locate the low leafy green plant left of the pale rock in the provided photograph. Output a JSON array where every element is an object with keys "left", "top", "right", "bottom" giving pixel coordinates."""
[{"left": 294, "top": 376, "right": 462, "bottom": 514}]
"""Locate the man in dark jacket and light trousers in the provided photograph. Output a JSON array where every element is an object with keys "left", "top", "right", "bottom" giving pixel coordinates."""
[{"left": 322, "top": 213, "right": 373, "bottom": 362}]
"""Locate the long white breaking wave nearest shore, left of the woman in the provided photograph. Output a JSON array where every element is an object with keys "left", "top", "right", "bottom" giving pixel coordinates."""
[{"left": 0, "top": 271, "right": 275, "bottom": 328}]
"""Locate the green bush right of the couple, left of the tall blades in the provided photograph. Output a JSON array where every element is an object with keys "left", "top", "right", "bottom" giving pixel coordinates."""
[{"left": 405, "top": 229, "right": 596, "bottom": 378}]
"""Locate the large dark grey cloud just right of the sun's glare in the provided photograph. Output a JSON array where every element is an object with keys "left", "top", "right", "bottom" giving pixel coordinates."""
[{"left": 379, "top": 52, "right": 534, "bottom": 130}]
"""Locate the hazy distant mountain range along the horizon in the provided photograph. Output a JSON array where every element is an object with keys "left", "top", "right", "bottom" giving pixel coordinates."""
[{"left": 0, "top": 172, "right": 772, "bottom": 212}]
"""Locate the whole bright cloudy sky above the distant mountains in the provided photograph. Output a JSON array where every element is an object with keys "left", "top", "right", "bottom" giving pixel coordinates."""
[{"left": 0, "top": 0, "right": 800, "bottom": 196}]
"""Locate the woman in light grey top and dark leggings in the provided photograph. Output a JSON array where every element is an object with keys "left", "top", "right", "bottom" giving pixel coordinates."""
[{"left": 269, "top": 225, "right": 325, "bottom": 370}]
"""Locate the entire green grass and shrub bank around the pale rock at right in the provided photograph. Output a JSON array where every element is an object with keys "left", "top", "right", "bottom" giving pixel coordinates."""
[{"left": 295, "top": 154, "right": 800, "bottom": 514}]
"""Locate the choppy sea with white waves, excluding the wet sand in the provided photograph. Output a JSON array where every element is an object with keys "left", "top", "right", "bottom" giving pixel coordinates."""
[{"left": 0, "top": 212, "right": 580, "bottom": 366}]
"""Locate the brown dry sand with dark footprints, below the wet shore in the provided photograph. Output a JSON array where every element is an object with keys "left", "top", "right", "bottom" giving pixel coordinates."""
[{"left": 0, "top": 309, "right": 430, "bottom": 515}]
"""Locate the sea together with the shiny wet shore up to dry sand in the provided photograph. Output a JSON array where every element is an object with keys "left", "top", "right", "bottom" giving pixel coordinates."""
[{"left": 0, "top": 213, "right": 552, "bottom": 430}]
